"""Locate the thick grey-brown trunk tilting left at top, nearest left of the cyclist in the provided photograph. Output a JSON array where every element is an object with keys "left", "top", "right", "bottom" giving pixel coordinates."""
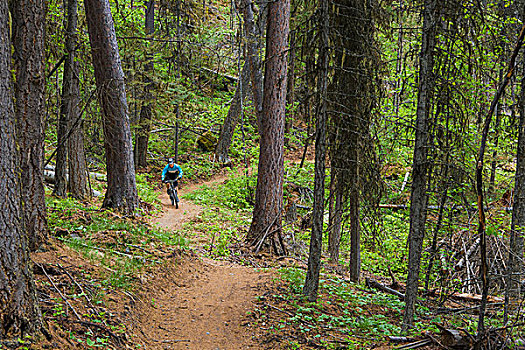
[{"left": 84, "top": 0, "right": 139, "bottom": 214}]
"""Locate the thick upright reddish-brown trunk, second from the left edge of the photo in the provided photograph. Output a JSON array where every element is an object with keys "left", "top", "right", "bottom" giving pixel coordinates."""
[{"left": 11, "top": 0, "right": 48, "bottom": 250}]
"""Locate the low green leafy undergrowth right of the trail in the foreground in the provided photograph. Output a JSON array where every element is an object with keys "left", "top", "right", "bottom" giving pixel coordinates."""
[{"left": 262, "top": 268, "right": 403, "bottom": 346}]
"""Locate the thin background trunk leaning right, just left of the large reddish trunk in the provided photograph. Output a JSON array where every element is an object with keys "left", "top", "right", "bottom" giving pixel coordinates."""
[{"left": 215, "top": 53, "right": 250, "bottom": 164}]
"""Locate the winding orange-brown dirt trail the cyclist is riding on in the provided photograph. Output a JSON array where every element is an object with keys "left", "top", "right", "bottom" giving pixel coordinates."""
[{"left": 135, "top": 178, "right": 270, "bottom": 350}]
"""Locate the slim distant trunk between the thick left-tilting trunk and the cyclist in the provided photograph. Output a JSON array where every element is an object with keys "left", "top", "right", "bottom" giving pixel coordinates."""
[{"left": 135, "top": 0, "right": 155, "bottom": 168}]
